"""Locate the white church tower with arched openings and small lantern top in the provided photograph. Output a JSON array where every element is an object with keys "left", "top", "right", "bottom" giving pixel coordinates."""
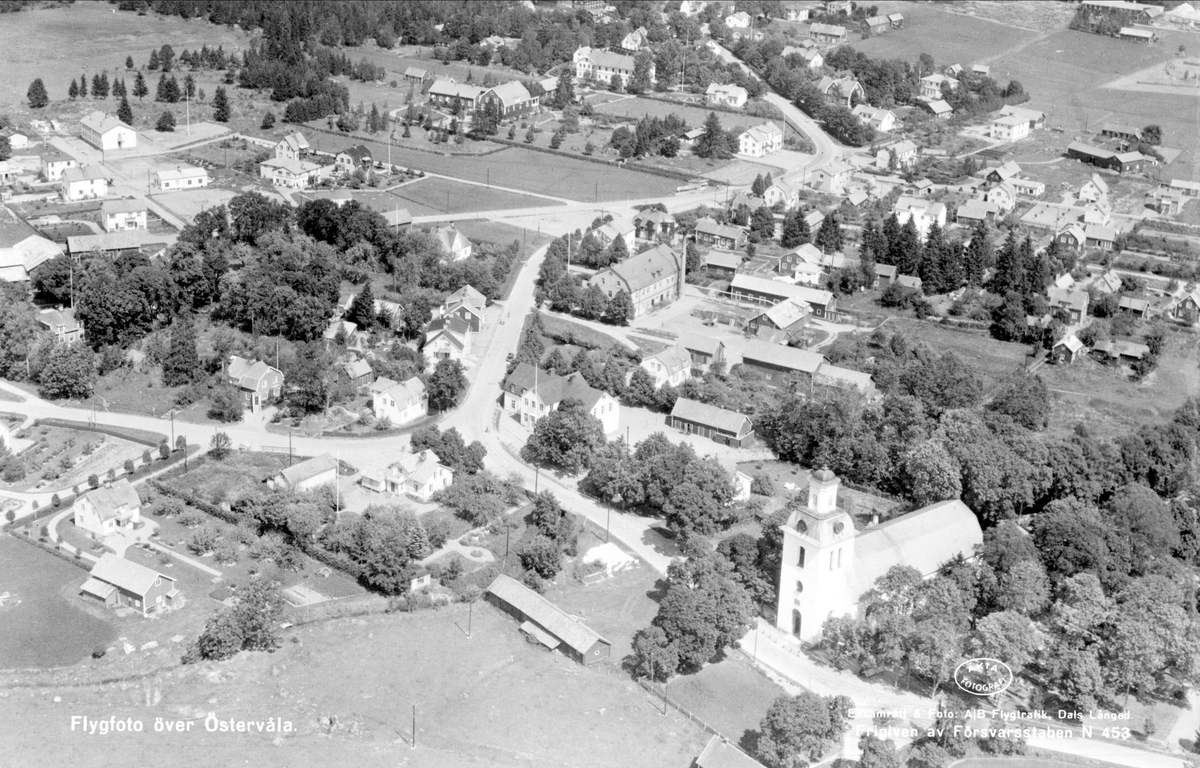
[{"left": 775, "top": 469, "right": 857, "bottom": 642}]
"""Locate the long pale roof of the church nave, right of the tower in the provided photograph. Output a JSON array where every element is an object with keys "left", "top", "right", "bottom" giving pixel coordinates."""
[{"left": 851, "top": 499, "right": 983, "bottom": 599}]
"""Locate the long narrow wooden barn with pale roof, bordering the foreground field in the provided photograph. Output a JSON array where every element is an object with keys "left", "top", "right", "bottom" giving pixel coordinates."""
[{"left": 485, "top": 574, "right": 612, "bottom": 666}]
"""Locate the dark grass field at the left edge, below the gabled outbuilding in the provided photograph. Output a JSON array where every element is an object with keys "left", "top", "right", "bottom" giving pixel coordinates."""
[{"left": 0, "top": 534, "right": 116, "bottom": 670}]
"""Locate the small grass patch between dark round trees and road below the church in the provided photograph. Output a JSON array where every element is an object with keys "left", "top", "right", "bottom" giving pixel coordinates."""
[{"left": 667, "top": 654, "right": 786, "bottom": 743}]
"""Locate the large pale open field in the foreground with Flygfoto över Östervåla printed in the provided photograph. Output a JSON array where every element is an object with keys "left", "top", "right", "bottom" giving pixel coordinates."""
[{"left": 0, "top": 604, "right": 708, "bottom": 768}]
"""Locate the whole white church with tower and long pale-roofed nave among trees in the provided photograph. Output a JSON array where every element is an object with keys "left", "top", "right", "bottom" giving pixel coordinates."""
[{"left": 775, "top": 469, "right": 983, "bottom": 642}]
